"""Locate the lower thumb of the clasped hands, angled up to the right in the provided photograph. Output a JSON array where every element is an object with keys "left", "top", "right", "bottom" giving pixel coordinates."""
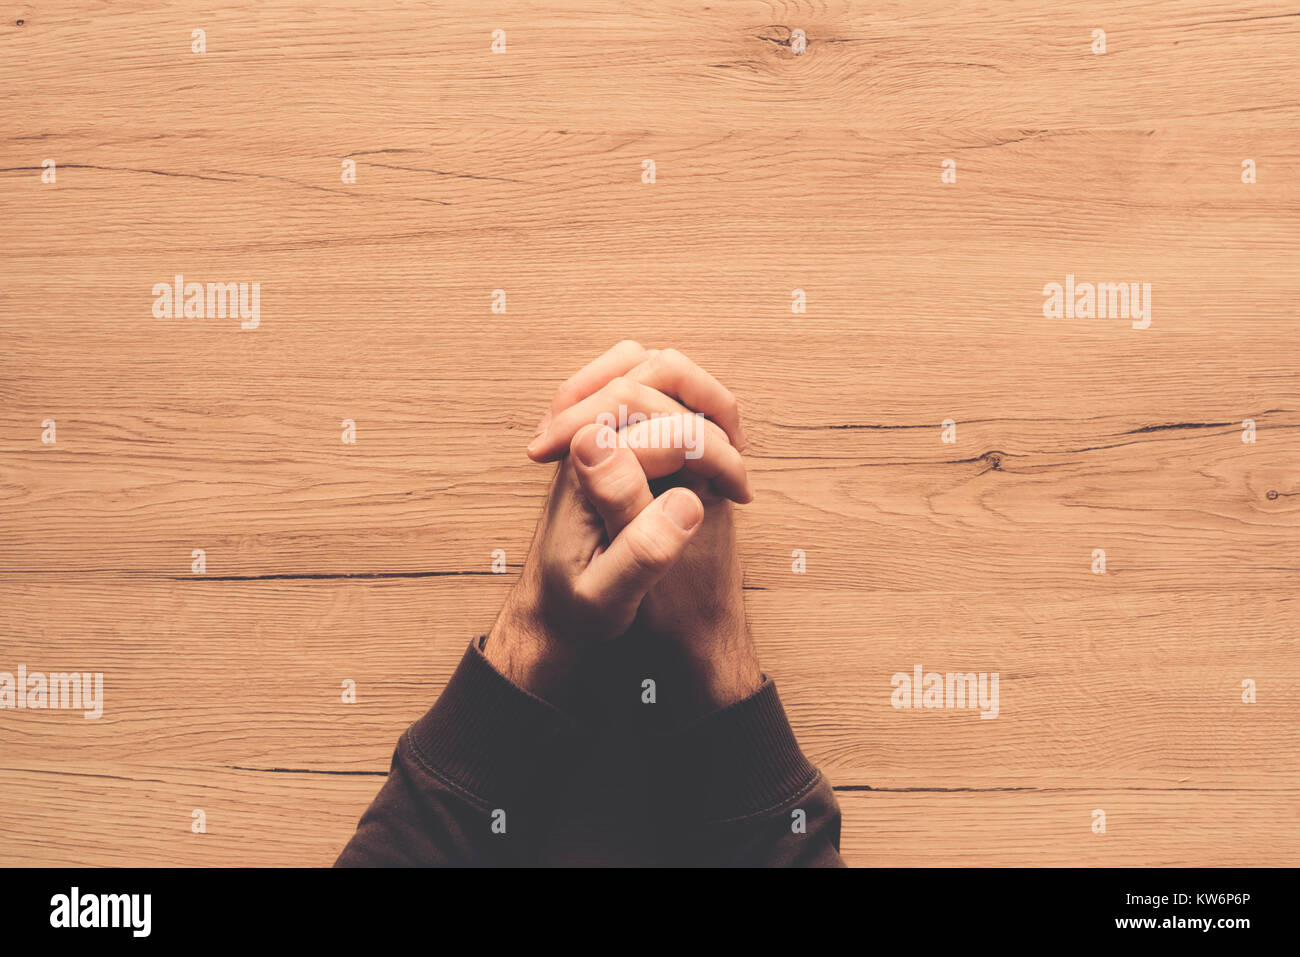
[{"left": 576, "top": 488, "right": 705, "bottom": 635}]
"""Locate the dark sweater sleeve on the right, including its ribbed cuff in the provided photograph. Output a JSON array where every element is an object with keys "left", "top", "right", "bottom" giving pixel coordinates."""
[{"left": 651, "top": 677, "right": 844, "bottom": 867}]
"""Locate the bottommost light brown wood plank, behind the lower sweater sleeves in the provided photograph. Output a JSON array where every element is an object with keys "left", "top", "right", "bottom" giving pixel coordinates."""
[{"left": 0, "top": 763, "right": 1300, "bottom": 867}]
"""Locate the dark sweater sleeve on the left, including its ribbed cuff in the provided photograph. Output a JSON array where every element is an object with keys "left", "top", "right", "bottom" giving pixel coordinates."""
[{"left": 334, "top": 641, "right": 582, "bottom": 867}]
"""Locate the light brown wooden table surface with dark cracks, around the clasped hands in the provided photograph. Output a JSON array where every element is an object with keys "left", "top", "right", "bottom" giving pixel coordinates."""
[{"left": 0, "top": 0, "right": 1300, "bottom": 865}]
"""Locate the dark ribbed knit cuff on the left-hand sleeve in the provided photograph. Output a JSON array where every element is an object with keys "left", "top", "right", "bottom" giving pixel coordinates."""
[{"left": 404, "top": 638, "right": 584, "bottom": 804}]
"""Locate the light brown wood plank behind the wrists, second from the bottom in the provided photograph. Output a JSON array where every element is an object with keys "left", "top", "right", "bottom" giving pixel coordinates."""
[{"left": 0, "top": 575, "right": 1300, "bottom": 788}]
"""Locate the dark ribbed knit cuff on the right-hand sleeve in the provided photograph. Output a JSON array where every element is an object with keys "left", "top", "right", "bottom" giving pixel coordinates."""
[{"left": 650, "top": 679, "right": 818, "bottom": 822}]
